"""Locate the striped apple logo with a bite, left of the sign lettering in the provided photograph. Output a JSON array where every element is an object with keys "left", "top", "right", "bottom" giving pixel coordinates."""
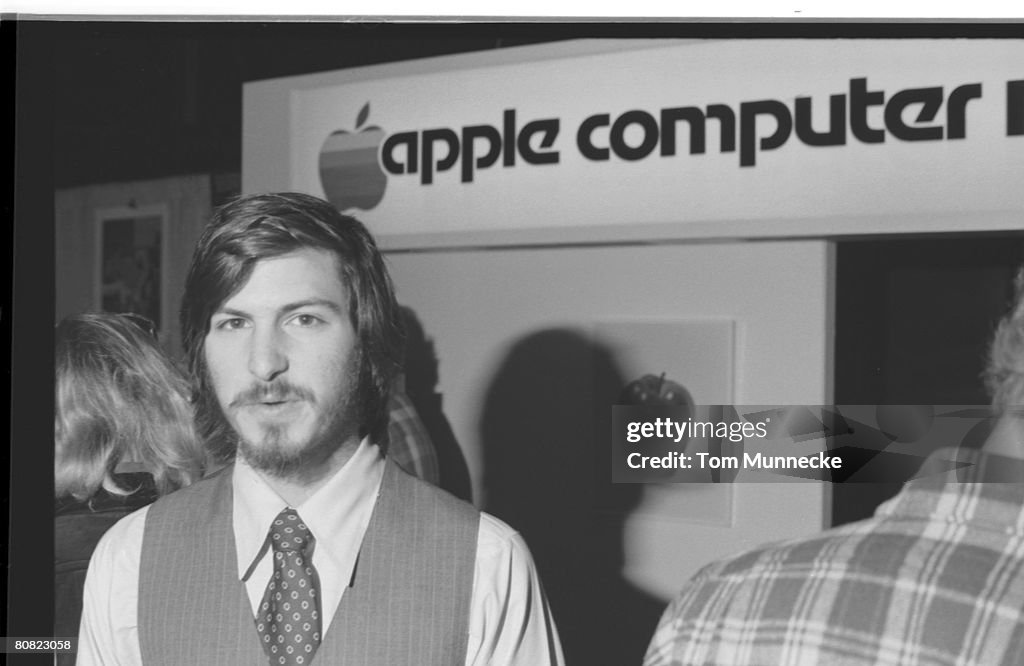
[{"left": 319, "top": 101, "right": 387, "bottom": 210}]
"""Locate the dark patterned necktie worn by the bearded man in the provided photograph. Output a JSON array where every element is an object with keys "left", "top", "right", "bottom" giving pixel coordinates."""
[{"left": 256, "top": 508, "right": 321, "bottom": 666}]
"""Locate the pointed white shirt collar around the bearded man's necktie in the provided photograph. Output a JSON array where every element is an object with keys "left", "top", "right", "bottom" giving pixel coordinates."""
[{"left": 231, "top": 439, "right": 384, "bottom": 584}]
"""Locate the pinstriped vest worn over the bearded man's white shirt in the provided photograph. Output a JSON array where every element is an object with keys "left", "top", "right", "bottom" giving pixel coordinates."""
[{"left": 138, "top": 461, "right": 480, "bottom": 666}]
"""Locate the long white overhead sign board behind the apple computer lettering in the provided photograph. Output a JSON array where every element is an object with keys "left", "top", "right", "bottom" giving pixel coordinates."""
[{"left": 244, "top": 39, "right": 1024, "bottom": 243}]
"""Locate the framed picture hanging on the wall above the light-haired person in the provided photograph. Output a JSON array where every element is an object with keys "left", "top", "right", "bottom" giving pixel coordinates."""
[{"left": 94, "top": 204, "right": 168, "bottom": 334}]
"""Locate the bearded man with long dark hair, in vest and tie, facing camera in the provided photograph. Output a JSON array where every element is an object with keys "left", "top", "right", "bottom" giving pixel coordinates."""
[{"left": 78, "top": 194, "right": 562, "bottom": 666}]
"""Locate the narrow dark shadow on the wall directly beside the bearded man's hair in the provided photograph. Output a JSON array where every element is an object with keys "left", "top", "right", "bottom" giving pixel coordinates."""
[{"left": 401, "top": 305, "right": 473, "bottom": 502}]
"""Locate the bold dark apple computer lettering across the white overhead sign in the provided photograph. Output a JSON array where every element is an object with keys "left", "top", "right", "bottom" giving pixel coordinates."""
[{"left": 372, "top": 78, "right": 1024, "bottom": 184}]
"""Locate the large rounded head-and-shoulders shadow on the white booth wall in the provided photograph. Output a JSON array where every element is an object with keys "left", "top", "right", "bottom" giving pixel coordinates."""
[{"left": 480, "top": 329, "right": 665, "bottom": 666}]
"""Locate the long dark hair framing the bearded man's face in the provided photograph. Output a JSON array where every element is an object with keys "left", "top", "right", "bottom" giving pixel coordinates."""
[{"left": 181, "top": 193, "right": 403, "bottom": 461}]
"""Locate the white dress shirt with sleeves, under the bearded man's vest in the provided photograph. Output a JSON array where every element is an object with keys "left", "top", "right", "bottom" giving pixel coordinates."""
[{"left": 77, "top": 441, "right": 563, "bottom": 666}]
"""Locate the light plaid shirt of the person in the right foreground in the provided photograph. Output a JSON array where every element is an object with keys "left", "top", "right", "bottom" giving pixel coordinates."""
[{"left": 644, "top": 450, "right": 1024, "bottom": 666}]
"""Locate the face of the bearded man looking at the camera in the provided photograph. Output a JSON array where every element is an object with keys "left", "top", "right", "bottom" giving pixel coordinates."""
[{"left": 204, "top": 249, "right": 359, "bottom": 476}]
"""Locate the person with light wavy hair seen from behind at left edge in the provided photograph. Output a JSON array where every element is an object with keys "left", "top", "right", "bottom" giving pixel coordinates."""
[{"left": 53, "top": 314, "right": 206, "bottom": 663}]
